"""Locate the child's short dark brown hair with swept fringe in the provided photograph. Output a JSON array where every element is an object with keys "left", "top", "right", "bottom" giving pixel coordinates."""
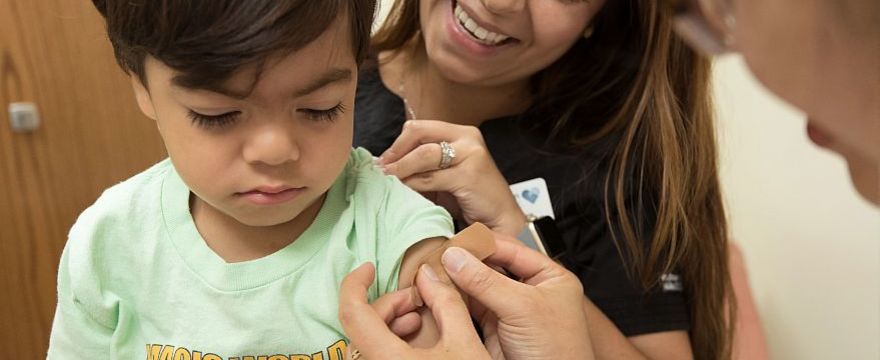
[{"left": 92, "top": 0, "right": 376, "bottom": 93}]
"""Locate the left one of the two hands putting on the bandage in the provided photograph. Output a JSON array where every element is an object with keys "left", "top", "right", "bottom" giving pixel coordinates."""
[{"left": 339, "top": 264, "right": 489, "bottom": 360}]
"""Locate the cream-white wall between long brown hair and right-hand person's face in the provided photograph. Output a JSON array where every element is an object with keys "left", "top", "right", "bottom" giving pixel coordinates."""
[{"left": 715, "top": 56, "right": 880, "bottom": 359}]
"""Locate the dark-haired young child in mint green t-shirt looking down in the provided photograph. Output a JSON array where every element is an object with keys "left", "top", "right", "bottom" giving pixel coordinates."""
[{"left": 48, "top": 0, "right": 452, "bottom": 360}]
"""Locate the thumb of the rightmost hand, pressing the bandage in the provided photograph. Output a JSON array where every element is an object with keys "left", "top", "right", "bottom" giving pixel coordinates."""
[{"left": 441, "top": 247, "right": 527, "bottom": 318}]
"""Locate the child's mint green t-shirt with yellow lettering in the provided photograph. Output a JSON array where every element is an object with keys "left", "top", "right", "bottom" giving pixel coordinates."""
[{"left": 48, "top": 149, "right": 452, "bottom": 360}]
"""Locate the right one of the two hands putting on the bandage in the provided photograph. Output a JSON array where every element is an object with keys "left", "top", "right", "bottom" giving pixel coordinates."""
[{"left": 442, "top": 234, "right": 593, "bottom": 359}]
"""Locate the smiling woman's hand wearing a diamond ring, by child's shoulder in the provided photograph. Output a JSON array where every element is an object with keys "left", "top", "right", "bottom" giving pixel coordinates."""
[{"left": 377, "top": 120, "right": 526, "bottom": 236}]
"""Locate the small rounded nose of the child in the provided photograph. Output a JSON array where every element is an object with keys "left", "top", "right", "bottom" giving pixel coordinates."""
[{"left": 243, "top": 124, "right": 300, "bottom": 166}]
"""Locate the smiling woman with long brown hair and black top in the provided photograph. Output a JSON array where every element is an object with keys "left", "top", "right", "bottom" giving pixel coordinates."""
[{"left": 355, "top": 0, "right": 729, "bottom": 359}]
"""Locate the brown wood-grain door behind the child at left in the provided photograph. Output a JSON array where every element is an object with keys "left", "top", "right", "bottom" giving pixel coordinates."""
[{"left": 0, "top": 0, "right": 164, "bottom": 359}]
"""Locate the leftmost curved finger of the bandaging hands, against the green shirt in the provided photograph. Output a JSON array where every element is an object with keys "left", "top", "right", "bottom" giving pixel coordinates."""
[{"left": 339, "top": 263, "right": 407, "bottom": 359}]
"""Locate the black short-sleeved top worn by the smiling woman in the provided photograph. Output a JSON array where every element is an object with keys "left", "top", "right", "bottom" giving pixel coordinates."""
[{"left": 354, "top": 66, "right": 689, "bottom": 336}]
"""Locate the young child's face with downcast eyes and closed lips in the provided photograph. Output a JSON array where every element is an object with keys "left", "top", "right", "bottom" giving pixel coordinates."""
[{"left": 133, "top": 26, "right": 357, "bottom": 226}]
